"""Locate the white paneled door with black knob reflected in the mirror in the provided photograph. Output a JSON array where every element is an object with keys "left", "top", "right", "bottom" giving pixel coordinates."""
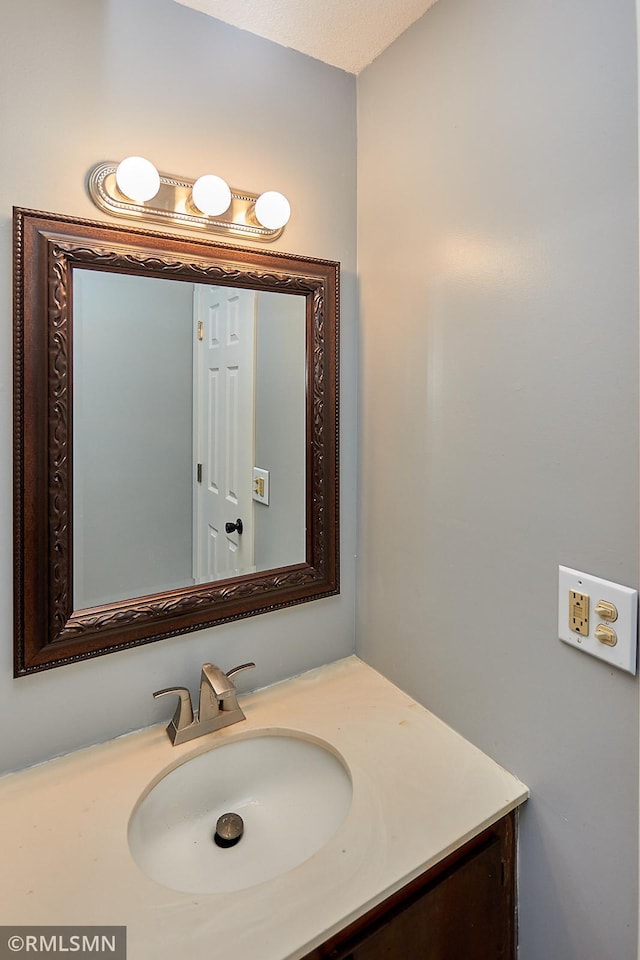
[{"left": 193, "top": 283, "right": 256, "bottom": 583}]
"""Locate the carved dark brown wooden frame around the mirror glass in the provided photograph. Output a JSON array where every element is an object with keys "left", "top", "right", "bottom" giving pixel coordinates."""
[{"left": 14, "top": 208, "right": 339, "bottom": 676}]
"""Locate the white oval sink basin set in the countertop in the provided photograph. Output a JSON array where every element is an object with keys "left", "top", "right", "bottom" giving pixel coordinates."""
[{"left": 129, "top": 733, "right": 352, "bottom": 893}]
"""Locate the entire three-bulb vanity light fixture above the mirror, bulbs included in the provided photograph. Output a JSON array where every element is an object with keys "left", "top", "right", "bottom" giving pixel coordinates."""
[{"left": 88, "top": 157, "right": 291, "bottom": 242}]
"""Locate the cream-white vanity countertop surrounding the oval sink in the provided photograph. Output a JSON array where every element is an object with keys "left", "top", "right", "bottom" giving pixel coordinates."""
[{"left": 0, "top": 657, "right": 528, "bottom": 960}]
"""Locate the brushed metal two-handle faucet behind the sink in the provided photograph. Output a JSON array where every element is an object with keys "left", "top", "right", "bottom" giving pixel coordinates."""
[{"left": 153, "top": 663, "right": 255, "bottom": 746}]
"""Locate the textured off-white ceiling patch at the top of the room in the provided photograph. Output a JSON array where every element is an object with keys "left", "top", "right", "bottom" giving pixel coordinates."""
[{"left": 172, "top": 0, "right": 435, "bottom": 73}]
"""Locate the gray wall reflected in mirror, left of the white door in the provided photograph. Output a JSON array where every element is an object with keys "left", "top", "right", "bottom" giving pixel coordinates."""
[{"left": 73, "top": 270, "right": 194, "bottom": 609}]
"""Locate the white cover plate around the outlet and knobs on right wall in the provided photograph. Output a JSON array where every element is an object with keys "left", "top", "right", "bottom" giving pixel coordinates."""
[{"left": 558, "top": 566, "right": 638, "bottom": 674}]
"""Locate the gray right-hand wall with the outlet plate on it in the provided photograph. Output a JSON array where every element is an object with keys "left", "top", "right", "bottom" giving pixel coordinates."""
[{"left": 358, "top": 0, "right": 638, "bottom": 960}]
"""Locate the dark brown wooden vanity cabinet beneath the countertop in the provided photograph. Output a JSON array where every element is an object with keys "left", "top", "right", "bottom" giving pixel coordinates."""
[{"left": 303, "top": 813, "right": 516, "bottom": 960}]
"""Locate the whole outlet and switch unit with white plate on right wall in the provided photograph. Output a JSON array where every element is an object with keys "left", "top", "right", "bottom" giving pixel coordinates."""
[{"left": 558, "top": 566, "right": 638, "bottom": 674}]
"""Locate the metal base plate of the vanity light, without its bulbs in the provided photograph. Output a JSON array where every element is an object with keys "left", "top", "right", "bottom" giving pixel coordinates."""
[{"left": 87, "top": 161, "right": 284, "bottom": 243}]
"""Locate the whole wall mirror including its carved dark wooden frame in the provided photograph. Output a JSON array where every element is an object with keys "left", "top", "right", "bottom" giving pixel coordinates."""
[{"left": 14, "top": 209, "right": 339, "bottom": 676}]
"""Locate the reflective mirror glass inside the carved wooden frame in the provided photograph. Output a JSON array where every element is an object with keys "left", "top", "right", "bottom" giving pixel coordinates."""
[{"left": 73, "top": 269, "right": 306, "bottom": 608}]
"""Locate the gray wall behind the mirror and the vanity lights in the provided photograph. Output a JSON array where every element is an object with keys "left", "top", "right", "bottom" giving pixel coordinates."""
[{"left": 0, "top": 0, "right": 356, "bottom": 770}]
